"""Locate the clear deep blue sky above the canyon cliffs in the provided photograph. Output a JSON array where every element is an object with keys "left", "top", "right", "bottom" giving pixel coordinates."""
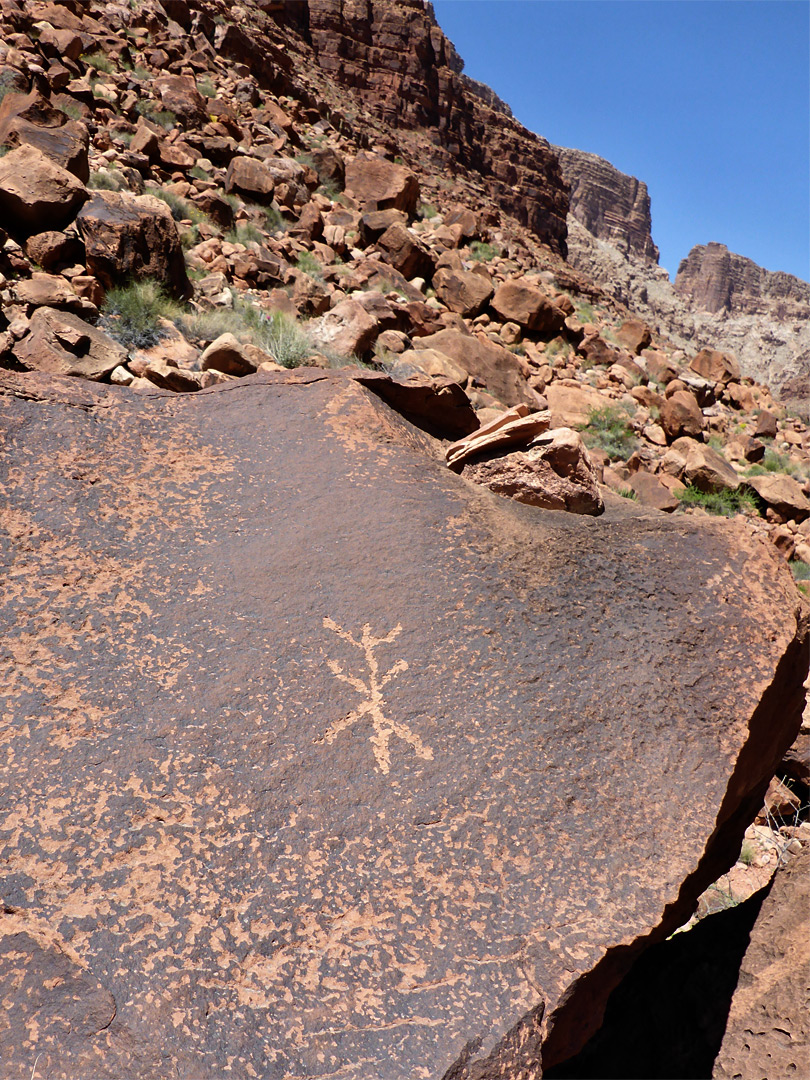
[{"left": 433, "top": 0, "right": 810, "bottom": 281}]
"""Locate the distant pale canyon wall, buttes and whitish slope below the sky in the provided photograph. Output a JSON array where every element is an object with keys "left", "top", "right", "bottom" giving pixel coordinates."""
[{"left": 555, "top": 158, "right": 810, "bottom": 406}]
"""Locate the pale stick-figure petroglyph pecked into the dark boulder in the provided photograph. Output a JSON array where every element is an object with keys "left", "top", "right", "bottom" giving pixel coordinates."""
[{"left": 323, "top": 619, "right": 433, "bottom": 773}]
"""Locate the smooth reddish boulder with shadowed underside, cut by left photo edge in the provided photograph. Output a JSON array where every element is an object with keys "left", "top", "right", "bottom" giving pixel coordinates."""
[{"left": 0, "top": 145, "right": 89, "bottom": 235}]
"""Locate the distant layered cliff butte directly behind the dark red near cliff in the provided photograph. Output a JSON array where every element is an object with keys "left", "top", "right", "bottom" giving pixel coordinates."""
[{"left": 554, "top": 146, "right": 658, "bottom": 262}]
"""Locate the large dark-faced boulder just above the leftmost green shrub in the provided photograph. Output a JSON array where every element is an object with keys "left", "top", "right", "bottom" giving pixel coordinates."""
[{"left": 77, "top": 191, "right": 191, "bottom": 297}]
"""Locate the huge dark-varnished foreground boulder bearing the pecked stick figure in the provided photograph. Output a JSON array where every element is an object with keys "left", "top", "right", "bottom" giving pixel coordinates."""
[{"left": 0, "top": 369, "right": 806, "bottom": 1080}]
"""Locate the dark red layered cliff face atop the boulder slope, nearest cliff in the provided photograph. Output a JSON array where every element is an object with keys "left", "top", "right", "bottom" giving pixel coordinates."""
[{"left": 294, "top": 0, "right": 568, "bottom": 253}]
